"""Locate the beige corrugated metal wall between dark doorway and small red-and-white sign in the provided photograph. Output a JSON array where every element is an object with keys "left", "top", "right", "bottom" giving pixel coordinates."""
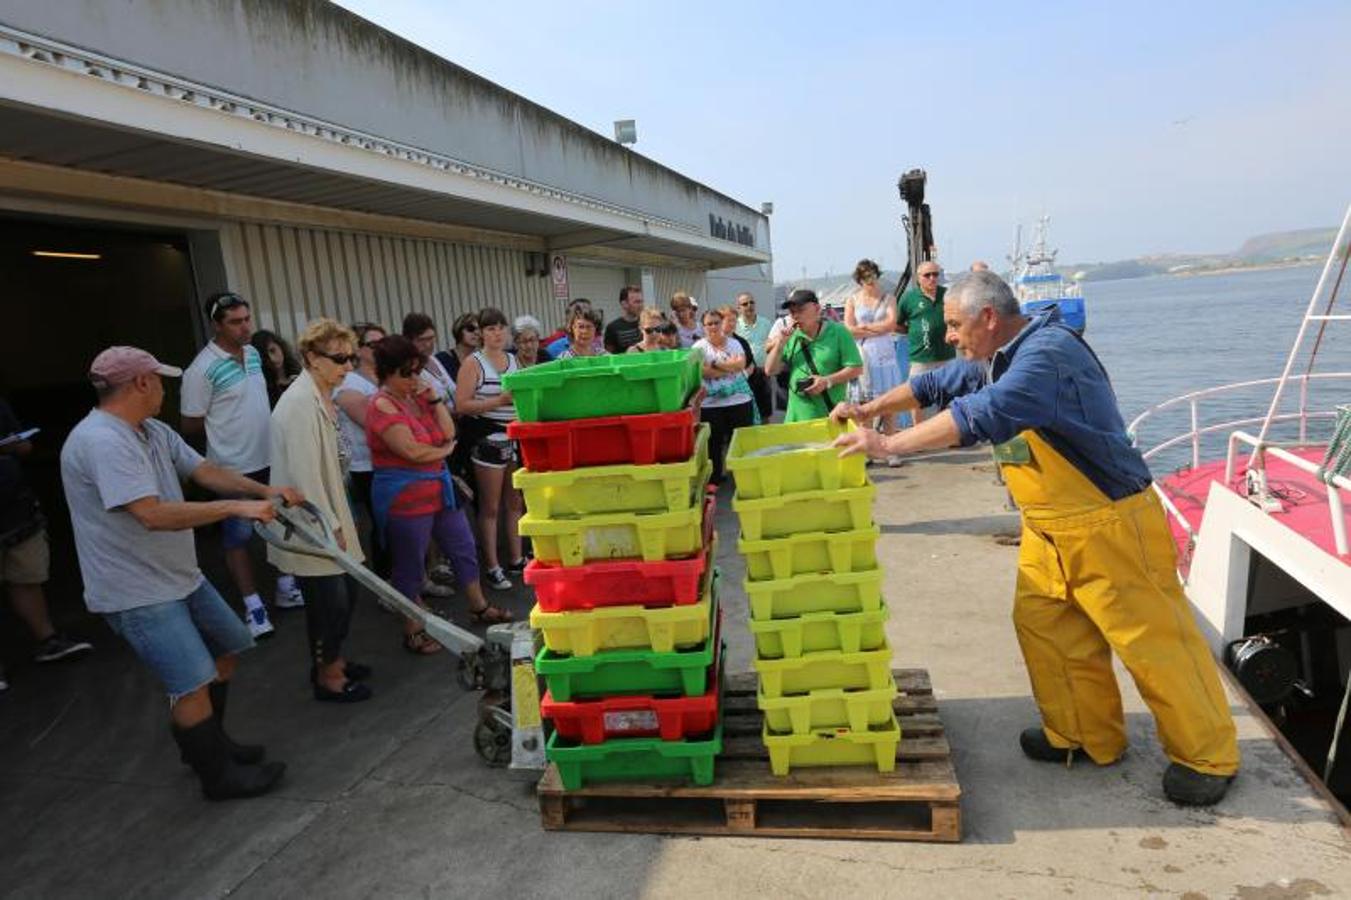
[{"left": 220, "top": 223, "right": 561, "bottom": 343}]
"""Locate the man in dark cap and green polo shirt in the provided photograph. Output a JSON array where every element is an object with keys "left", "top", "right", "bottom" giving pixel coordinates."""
[{"left": 765, "top": 289, "right": 863, "bottom": 422}]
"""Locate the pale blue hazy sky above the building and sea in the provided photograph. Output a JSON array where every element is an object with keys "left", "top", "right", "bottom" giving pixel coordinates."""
[{"left": 342, "top": 0, "right": 1351, "bottom": 280}]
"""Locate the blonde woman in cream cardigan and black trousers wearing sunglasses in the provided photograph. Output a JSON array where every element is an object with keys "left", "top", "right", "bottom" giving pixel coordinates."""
[{"left": 267, "top": 319, "right": 370, "bottom": 703}]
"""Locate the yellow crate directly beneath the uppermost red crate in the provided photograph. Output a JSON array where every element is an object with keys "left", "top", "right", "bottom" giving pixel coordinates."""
[{"left": 512, "top": 424, "right": 712, "bottom": 519}]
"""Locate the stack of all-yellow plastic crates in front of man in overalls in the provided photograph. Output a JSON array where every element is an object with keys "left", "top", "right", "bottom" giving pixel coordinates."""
[{"left": 727, "top": 419, "right": 901, "bottom": 774}]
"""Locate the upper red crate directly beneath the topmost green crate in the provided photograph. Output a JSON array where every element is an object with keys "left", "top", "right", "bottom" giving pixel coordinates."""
[{"left": 507, "top": 409, "right": 697, "bottom": 472}]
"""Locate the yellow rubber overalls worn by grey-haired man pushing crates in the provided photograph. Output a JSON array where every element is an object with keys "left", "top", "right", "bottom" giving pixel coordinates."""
[{"left": 996, "top": 430, "right": 1239, "bottom": 776}]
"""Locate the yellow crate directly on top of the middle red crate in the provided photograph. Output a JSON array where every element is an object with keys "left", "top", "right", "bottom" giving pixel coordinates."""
[{"left": 520, "top": 494, "right": 712, "bottom": 566}]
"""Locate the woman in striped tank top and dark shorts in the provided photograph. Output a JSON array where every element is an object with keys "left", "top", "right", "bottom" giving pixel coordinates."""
[{"left": 455, "top": 308, "right": 526, "bottom": 591}]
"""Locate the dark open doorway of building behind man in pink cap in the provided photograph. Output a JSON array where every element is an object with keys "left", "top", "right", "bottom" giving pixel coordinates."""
[{"left": 0, "top": 214, "right": 199, "bottom": 664}]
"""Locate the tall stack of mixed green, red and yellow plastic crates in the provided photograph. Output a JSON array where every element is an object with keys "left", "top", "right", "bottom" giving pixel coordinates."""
[{"left": 504, "top": 351, "right": 721, "bottom": 791}]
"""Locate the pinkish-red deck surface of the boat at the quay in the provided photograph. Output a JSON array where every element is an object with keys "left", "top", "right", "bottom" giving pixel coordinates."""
[{"left": 1159, "top": 446, "right": 1351, "bottom": 572}]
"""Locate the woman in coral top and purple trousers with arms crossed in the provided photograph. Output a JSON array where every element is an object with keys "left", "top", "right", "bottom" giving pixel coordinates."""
[{"left": 366, "top": 335, "right": 512, "bottom": 655}]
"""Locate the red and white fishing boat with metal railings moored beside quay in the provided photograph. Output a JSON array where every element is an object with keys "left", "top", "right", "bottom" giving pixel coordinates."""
[{"left": 1129, "top": 209, "right": 1351, "bottom": 816}]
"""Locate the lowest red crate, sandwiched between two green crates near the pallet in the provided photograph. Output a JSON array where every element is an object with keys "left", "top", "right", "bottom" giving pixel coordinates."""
[{"left": 539, "top": 656, "right": 721, "bottom": 743}]
